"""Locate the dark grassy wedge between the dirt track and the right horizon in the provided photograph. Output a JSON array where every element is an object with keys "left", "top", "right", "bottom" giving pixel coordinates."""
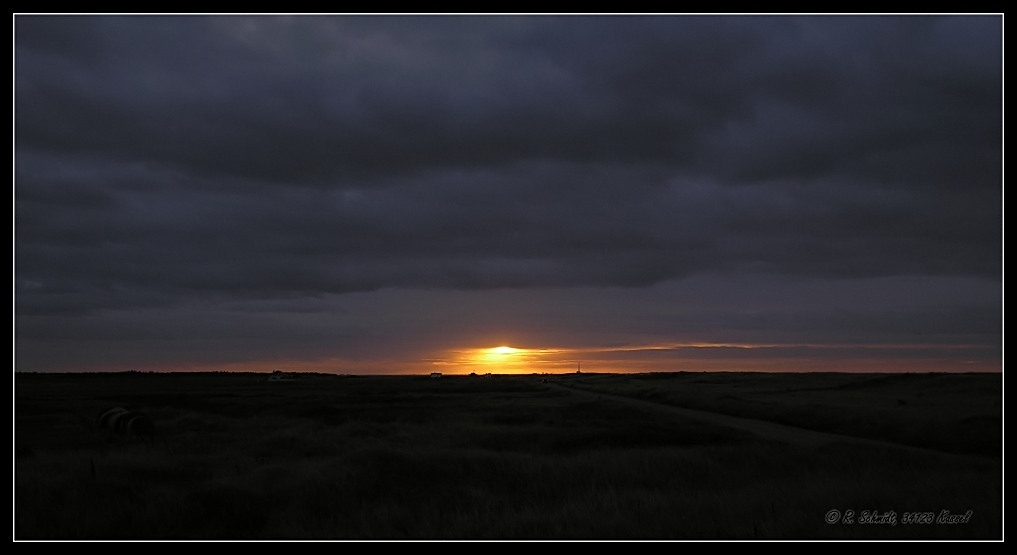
[{"left": 559, "top": 372, "right": 1003, "bottom": 457}]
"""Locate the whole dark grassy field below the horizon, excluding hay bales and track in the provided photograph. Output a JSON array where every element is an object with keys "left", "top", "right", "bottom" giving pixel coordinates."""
[{"left": 13, "top": 373, "right": 1003, "bottom": 541}]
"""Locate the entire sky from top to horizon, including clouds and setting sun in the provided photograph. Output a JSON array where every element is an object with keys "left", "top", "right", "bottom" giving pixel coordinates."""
[{"left": 12, "top": 14, "right": 1003, "bottom": 374}]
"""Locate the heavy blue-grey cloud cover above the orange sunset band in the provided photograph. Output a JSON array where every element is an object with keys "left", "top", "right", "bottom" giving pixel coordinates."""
[{"left": 14, "top": 15, "right": 1002, "bottom": 372}]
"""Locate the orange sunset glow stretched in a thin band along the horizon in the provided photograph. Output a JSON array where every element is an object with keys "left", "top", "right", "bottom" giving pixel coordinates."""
[{"left": 116, "top": 341, "right": 998, "bottom": 375}]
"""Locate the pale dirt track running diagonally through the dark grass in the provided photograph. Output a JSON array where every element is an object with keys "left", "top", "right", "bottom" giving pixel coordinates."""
[{"left": 544, "top": 382, "right": 984, "bottom": 458}]
